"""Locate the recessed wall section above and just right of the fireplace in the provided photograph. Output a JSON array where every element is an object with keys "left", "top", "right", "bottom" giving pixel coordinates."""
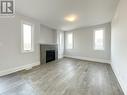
[{"left": 40, "top": 24, "right": 64, "bottom": 58}]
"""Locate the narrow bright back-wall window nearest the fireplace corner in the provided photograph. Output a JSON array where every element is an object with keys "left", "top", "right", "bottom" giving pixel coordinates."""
[{"left": 66, "top": 32, "right": 73, "bottom": 49}]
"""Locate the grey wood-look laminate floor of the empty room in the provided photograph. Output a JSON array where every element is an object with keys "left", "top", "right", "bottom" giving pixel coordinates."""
[{"left": 0, "top": 58, "right": 124, "bottom": 95}]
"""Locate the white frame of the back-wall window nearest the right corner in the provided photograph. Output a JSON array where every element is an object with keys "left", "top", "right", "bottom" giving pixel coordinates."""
[{"left": 93, "top": 28, "right": 105, "bottom": 51}]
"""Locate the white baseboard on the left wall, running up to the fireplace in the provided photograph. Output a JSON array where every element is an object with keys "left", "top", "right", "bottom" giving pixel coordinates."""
[{"left": 0, "top": 62, "right": 40, "bottom": 76}]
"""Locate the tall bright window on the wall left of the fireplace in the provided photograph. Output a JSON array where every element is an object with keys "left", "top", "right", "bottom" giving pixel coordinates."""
[{"left": 22, "top": 22, "right": 34, "bottom": 52}]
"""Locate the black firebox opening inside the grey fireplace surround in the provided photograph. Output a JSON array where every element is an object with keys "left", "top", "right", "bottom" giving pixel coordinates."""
[{"left": 46, "top": 50, "right": 55, "bottom": 63}]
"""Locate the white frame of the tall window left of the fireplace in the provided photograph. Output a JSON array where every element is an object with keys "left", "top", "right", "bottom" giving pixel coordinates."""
[{"left": 21, "top": 20, "right": 34, "bottom": 53}]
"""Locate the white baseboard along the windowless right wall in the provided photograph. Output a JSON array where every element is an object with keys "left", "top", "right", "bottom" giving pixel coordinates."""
[{"left": 111, "top": 63, "right": 127, "bottom": 95}]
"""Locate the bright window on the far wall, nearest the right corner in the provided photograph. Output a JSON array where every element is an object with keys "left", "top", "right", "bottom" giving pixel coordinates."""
[{"left": 94, "top": 29, "right": 104, "bottom": 50}]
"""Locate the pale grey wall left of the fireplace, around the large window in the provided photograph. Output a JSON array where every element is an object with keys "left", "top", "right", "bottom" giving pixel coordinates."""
[{"left": 0, "top": 15, "right": 40, "bottom": 75}]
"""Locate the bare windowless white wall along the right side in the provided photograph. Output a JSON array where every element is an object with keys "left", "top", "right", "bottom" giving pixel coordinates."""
[{"left": 111, "top": 0, "right": 127, "bottom": 95}]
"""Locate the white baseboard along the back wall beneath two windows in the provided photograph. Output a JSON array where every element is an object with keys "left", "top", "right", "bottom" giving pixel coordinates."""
[{"left": 64, "top": 55, "right": 111, "bottom": 64}]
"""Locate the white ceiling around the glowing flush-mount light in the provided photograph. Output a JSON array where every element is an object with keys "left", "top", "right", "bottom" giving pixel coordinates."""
[{"left": 15, "top": 0, "right": 119, "bottom": 31}]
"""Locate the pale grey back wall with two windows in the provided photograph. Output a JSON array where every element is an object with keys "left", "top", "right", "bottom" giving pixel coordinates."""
[{"left": 65, "top": 23, "right": 111, "bottom": 62}]
